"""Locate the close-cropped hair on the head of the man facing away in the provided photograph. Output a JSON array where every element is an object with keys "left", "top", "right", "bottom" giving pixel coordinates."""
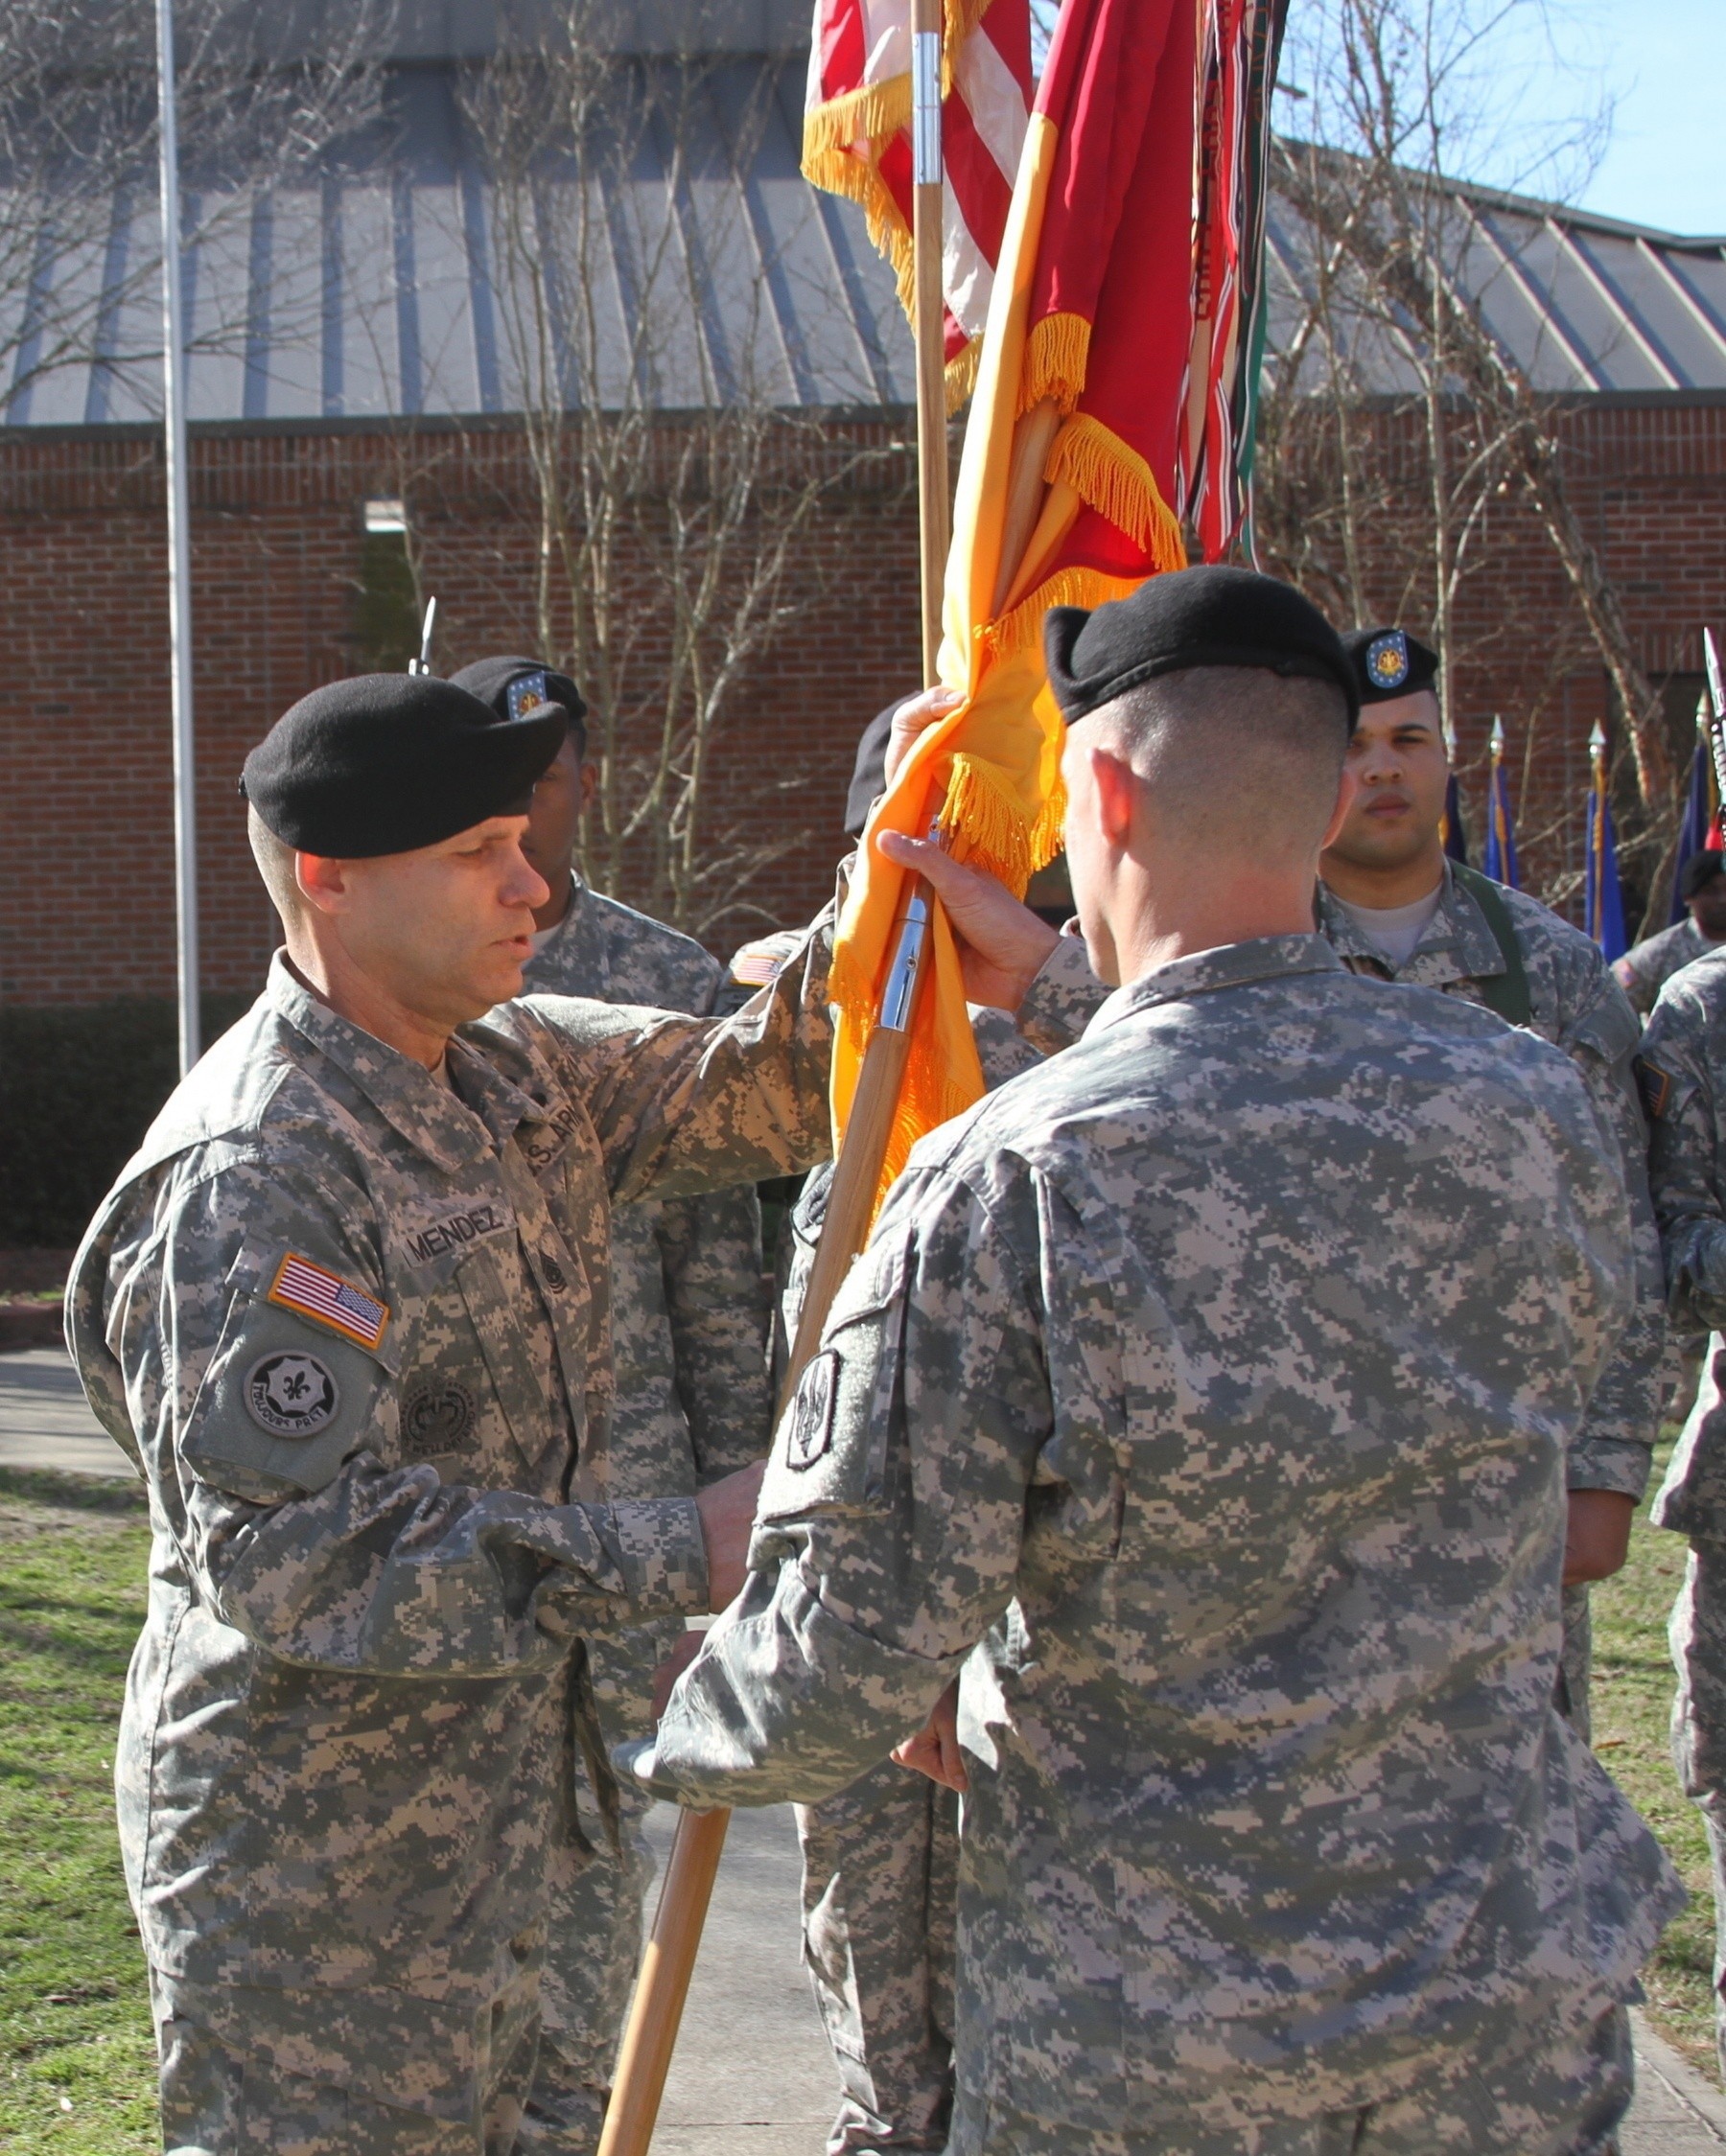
[{"left": 1094, "top": 666, "right": 1348, "bottom": 854}]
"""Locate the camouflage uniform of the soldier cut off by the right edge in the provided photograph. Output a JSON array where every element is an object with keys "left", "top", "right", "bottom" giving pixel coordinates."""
[{"left": 1640, "top": 951, "right": 1726, "bottom": 2063}]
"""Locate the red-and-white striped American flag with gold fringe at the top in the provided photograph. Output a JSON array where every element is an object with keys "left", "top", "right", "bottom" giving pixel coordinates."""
[{"left": 803, "top": 0, "right": 1032, "bottom": 406}]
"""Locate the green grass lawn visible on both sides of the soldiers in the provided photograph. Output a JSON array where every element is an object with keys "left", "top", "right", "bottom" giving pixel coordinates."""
[{"left": 0, "top": 1451, "right": 1717, "bottom": 2156}]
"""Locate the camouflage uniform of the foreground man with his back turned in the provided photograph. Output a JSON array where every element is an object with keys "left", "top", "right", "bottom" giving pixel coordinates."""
[{"left": 626, "top": 936, "right": 1683, "bottom": 2156}]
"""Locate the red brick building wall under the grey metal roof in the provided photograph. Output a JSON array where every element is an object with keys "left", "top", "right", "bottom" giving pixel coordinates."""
[{"left": 0, "top": 395, "right": 1726, "bottom": 1005}]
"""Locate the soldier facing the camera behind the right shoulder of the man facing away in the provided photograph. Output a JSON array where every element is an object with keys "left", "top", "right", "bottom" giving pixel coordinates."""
[{"left": 1318, "top": 630, "right": 1666, "bottom": 1735}]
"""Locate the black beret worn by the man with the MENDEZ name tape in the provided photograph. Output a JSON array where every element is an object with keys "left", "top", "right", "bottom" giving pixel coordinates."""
[{"left": 240, "top": 673, "right": 566, "bottom": 860}]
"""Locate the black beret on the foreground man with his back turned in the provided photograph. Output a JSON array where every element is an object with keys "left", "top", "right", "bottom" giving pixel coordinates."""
[{"left": 1042, "top": 567, "right": 1360, "bottom": 729}]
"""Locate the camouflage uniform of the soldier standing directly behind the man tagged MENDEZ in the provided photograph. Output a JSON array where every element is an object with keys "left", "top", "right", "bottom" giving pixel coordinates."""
[{"left": 518, "top": 877, "right": 770, "bottom": 2156}]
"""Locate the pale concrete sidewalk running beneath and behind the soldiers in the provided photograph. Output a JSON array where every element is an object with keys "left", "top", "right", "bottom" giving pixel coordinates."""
[{"left": 0, "top": 1348, "right": 1726, "bottom": 2156}]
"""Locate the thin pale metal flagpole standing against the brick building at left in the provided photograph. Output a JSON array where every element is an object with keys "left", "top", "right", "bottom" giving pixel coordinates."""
[{"left": 155, "top": 0, "right": 200, "bottom": 1076}]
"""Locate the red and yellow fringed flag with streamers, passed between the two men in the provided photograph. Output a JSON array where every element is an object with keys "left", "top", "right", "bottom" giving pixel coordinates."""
[{"left": 833, "top": 0, "right": 1286, "bottom": 1207}]
